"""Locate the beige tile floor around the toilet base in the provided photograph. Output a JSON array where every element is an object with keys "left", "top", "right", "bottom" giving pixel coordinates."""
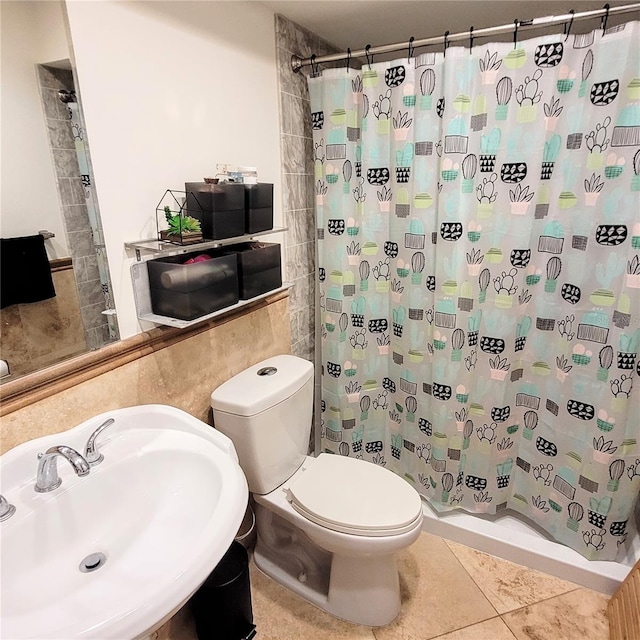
[{"left": 151, "top": 533, "right": 609, "bottom": 640}]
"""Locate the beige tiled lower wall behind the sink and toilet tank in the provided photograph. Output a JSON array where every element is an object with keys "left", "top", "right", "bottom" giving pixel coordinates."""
[{"left": 0, "top": 295, "right": 291, "bottom": 453}]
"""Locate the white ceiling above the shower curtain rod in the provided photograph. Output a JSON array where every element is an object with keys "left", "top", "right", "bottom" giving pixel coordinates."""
[{"left": 263, "top": 0, "right": 640, "bottom": 51}]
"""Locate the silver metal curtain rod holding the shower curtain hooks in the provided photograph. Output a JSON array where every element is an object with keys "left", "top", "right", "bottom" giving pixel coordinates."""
[{"left": 291, "top": 3, "right": 640, "bottom": 72}]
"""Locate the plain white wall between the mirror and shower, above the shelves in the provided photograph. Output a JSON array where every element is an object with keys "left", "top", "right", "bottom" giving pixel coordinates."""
[{"left": 66, "top": 0, "right": 281, "bottom": 338}]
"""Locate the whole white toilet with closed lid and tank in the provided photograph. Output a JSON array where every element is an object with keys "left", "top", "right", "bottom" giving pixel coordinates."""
[{"left": 211, "top": 355, "right": 422, "bottom": 627}]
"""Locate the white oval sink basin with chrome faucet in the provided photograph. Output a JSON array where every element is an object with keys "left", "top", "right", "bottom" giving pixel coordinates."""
[{"left": 0, "top": 405, "right": 248, "bottom": 640}]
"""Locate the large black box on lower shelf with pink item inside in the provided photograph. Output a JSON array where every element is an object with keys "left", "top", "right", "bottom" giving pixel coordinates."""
[{"left": 147, "top": 250, "right": 238, "bottom": 320}]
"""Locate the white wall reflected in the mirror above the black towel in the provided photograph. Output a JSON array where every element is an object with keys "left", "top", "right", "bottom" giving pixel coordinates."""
[{"left": 0, "top": 1, "right": 69, "bottom": 258}]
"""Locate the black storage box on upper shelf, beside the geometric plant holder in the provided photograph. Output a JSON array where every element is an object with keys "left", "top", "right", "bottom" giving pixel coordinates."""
[{"left": 184, "top": 182, "right": 245, "bottom": 240}]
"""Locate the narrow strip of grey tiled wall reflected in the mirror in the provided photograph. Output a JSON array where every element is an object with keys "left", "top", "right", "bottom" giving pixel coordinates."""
[{"left": 38, "top": 65, "right": 117, "bottom": 349}]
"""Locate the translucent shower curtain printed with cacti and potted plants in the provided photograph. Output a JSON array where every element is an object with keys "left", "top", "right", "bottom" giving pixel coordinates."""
[{"left": 309, "top": 22, "right": 640, "bottom": 560}]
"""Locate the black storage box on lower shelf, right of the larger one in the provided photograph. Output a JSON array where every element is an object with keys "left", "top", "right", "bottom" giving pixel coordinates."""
[{"left": 228, "top": 242, "right": 282, "bottom": 300}]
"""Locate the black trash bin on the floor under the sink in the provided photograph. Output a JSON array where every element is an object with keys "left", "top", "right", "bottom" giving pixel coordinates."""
[{"left": 191, "top": 541, "right": 256, "bottom": 640}]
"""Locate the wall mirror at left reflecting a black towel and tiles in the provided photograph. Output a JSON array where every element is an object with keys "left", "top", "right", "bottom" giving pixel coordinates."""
[{"left": 0, "top": 1, "right": 118, "bottom": 382}]
